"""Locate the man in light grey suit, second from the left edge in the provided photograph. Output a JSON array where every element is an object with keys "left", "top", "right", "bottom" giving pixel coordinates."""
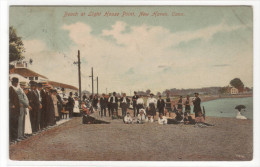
[{"left": 16, "top": 82, "right": 29, "bottom": 141}]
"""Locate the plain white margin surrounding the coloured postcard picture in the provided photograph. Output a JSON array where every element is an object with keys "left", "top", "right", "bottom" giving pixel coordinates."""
[{"left": 0, "top": 0, "right": 260, "bottom": 167}]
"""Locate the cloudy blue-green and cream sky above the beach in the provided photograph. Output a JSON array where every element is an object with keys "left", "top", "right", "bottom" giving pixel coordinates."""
[{"left": 10, "top": 6, "right": 253, "bottom": 94}]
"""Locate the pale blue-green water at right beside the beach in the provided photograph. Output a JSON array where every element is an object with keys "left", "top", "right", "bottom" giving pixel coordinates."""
[{"left": 196, "top": 97, "right": 253, "bottom": 119}]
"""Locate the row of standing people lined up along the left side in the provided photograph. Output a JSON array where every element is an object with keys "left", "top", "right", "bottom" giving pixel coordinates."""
[{"left": 9, "top": 64, "right": 78, "bottom": 143}]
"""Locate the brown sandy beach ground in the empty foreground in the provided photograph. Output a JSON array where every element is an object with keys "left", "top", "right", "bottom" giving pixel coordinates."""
[{"left": 10, "top": 111, "right": 253, "bottom": 161}]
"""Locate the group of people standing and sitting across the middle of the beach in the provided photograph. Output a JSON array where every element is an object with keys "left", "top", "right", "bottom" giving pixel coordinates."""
[{"left": 82, "top": 92, "right": 213, "bottom": 124}]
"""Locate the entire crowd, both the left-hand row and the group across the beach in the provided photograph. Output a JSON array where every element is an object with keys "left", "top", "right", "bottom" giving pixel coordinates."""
[{"left": 9, "top": 64, "right": 212, "bottom": 143}]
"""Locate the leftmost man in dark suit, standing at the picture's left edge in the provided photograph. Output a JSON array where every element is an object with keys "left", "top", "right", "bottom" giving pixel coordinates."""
[{"left": 9, "top": 77, "right": 20, "bottom": 141}]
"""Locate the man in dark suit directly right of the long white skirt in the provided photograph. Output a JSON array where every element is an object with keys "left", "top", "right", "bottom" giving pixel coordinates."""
[{"left": 28, "top": 81, "right": 40, "bottom": 133}]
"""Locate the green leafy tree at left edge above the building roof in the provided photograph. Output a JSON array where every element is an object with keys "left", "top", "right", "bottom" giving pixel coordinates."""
[{"left": 9, "top": 26, "right": 25, "bottom": 62}]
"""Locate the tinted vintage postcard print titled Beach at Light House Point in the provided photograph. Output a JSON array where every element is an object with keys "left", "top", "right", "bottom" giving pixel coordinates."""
[{"left": 9, "top": 6, "right": 254, "bottom": 161}]
